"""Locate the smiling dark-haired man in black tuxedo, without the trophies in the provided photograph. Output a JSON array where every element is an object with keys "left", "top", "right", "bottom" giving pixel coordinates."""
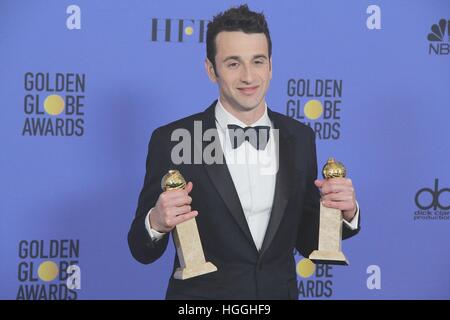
[{"left": 128, "top": 5, "right": 359, "bottom": 299}]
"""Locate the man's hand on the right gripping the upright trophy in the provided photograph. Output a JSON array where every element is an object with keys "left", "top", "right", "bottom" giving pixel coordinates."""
[{"left": 314, "top": 178, "right": 356, "bottom": 222}]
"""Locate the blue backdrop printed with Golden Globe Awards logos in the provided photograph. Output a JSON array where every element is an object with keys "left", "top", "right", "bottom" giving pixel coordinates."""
[{"left": 0, "top": 0, "right": 450, "bottom": 299}]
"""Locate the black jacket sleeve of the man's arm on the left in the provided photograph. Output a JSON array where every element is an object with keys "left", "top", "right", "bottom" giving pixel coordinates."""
[{"left": 128, "top": 129, "right": 171, "bottom": 264}]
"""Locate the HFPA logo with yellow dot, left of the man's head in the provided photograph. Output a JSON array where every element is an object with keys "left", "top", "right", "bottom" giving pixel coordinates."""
[{"left": 150, "top": 18, "right": 209, "bottom": 43}]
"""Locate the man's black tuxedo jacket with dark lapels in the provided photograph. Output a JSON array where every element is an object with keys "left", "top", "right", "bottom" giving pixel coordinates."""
[{"left": 128, "top": 101, "right": 359, "bottom": 299}]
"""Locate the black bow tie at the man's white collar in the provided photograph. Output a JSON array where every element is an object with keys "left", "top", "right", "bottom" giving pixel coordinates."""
[{"left": 228, "top": 124, "right": 270, "bottom": 150}]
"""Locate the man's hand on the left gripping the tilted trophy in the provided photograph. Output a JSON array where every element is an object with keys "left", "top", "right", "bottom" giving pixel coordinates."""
[{"left": 150, "top": 182, "right": 198, "bottom": 233}]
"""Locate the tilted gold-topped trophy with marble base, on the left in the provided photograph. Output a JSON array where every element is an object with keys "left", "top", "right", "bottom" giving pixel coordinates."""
[{"left": 161, "top": 170, "right": 217, "bottom": 280}]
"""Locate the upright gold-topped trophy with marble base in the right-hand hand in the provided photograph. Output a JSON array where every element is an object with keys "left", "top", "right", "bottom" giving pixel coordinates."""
[{"left": 309, "top": 158, "right": 348, "bottom": 265}]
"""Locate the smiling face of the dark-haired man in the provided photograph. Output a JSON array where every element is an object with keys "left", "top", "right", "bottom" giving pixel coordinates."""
[{"left": 205, "top": 31, "right": 272, "bottom": 112}]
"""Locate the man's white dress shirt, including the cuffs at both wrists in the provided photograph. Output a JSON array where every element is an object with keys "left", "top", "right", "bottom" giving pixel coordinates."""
[{"left": 145, "top": 99, "right": 359, "bottom": 250}]
